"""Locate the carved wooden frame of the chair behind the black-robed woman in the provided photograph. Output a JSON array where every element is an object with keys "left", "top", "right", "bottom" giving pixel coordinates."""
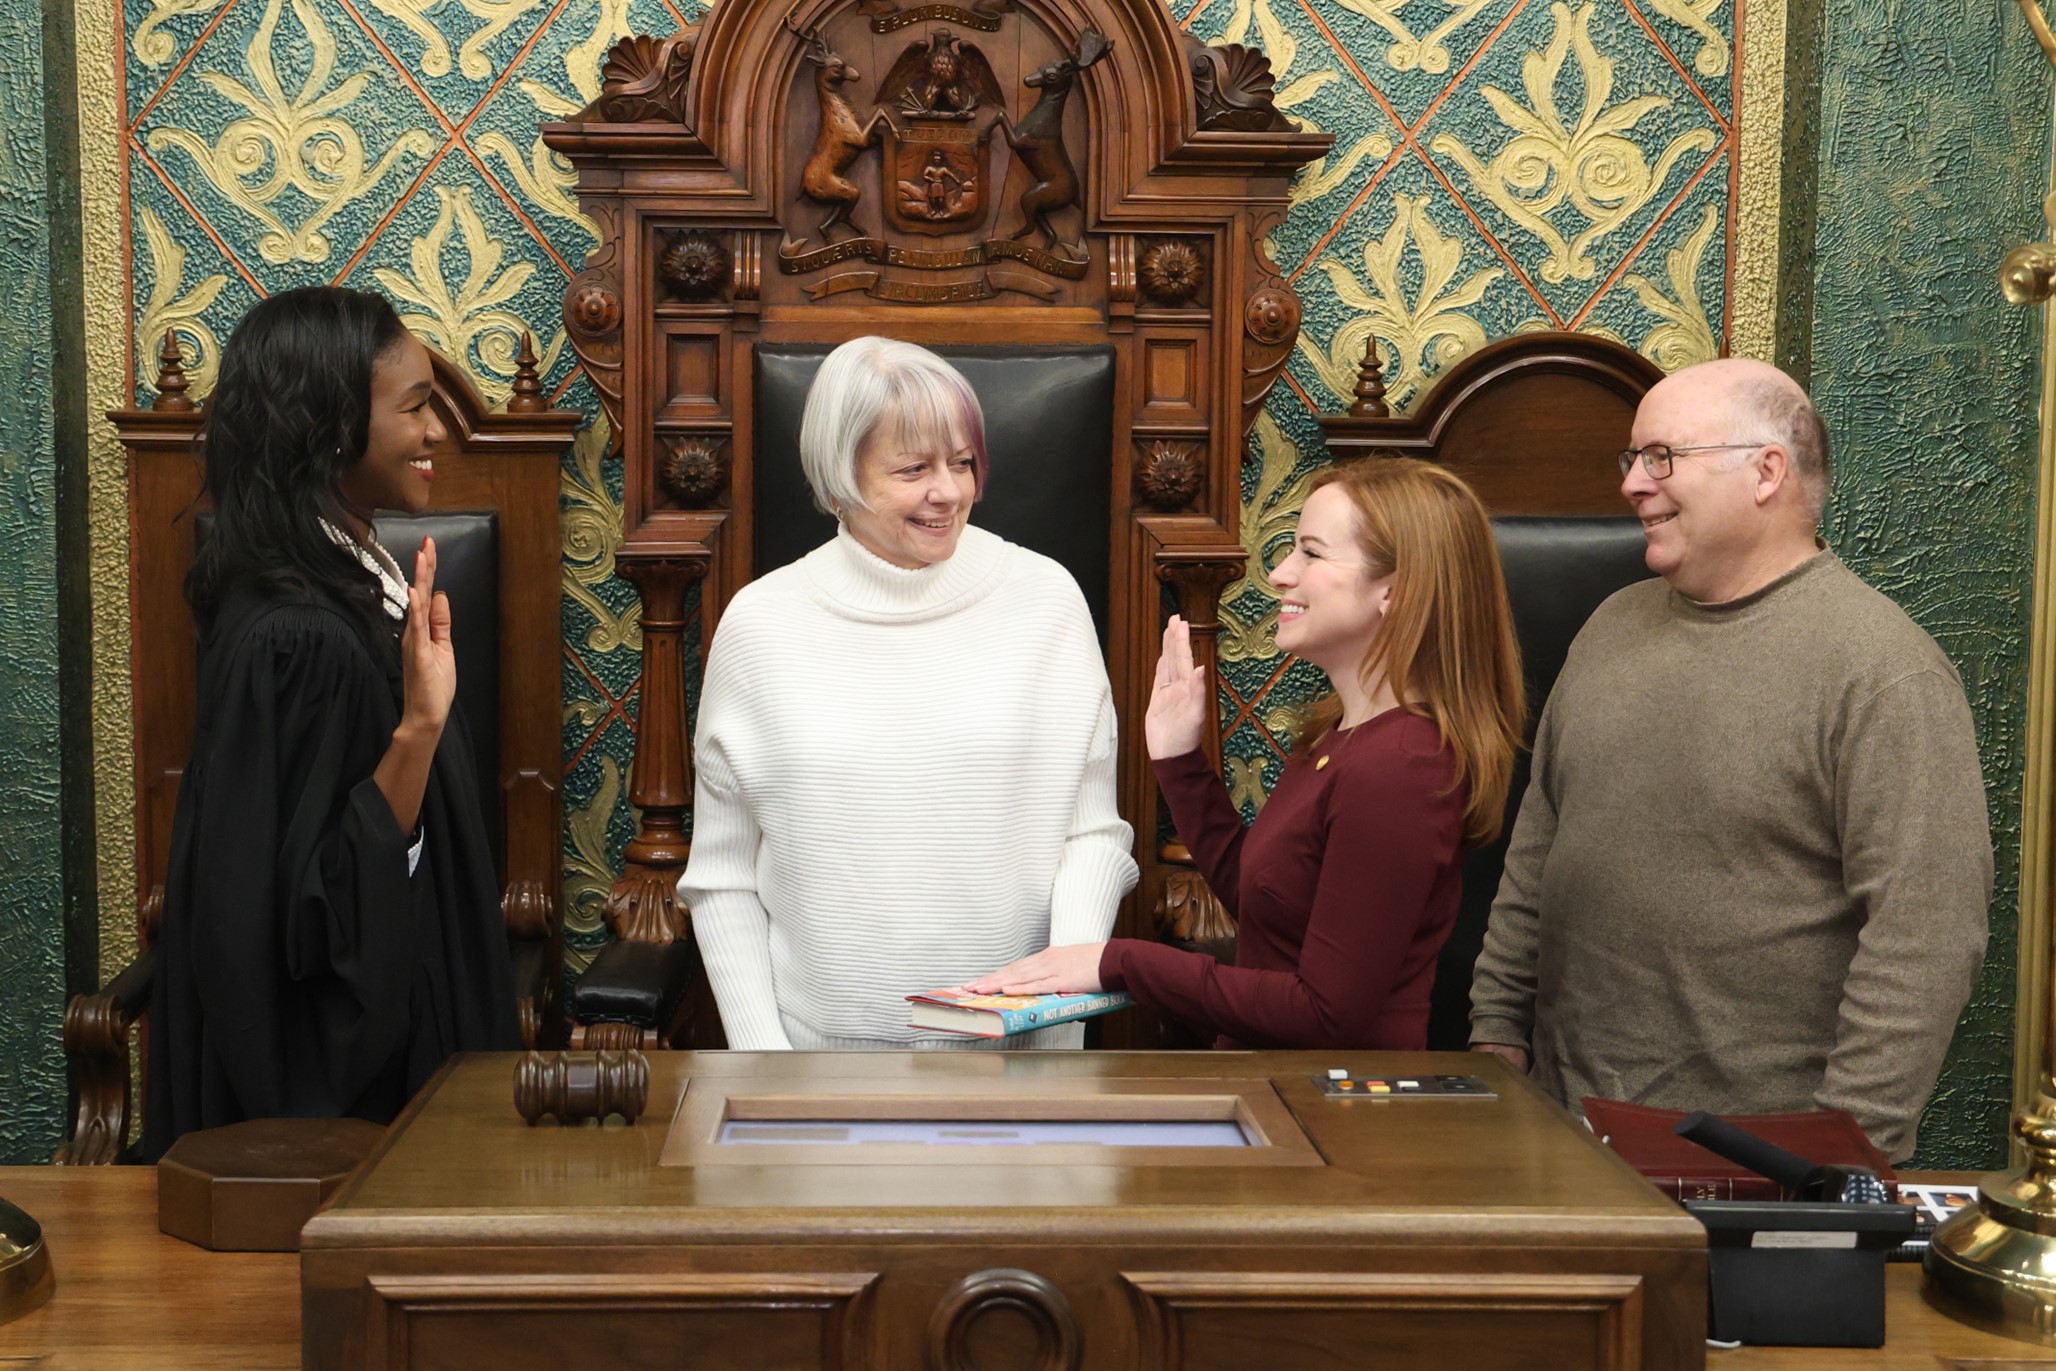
[{"left": 56, "top": 335, "right": 580, "bottom": 1165}]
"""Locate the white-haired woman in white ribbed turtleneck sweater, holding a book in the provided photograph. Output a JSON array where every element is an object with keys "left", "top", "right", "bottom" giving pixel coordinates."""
[{"left": 678, "top": 337, "right": 1135, "bottom": 1050}]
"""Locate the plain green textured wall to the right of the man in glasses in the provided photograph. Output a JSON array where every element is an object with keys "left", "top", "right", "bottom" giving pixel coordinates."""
[{"left": 1791, "top": 0, "right": 2050, "bottom": 1165}]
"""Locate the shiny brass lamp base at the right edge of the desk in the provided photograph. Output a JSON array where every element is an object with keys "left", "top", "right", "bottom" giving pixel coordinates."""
[{"left": 1922, "top": 1100, "right": 2056, "bottom": 1346}]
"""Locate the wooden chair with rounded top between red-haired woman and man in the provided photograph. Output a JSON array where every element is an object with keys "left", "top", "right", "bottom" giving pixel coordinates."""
[{"left": 1320, "top": 333, "right": 1663, "bottom": 1050}]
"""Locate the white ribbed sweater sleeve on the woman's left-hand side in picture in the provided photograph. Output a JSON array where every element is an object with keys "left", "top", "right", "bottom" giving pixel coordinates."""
[{"left": 678, "top": 735, "right": 792, "bottom": 1052}]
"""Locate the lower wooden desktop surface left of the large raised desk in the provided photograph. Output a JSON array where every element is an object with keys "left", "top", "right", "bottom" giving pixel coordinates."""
[{"left": 0, "top": 1165, "right": 300, "bottom": 1371}]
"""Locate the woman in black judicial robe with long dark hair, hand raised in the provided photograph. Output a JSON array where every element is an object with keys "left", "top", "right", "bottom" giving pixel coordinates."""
[{"left": 144, "top": 288, "right": 518, "bottom": 1157}]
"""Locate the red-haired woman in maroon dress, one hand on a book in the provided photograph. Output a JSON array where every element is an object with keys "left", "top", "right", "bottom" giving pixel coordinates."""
[{"left": 970, "top": 458, "right": 1523, "bottom": 1048}]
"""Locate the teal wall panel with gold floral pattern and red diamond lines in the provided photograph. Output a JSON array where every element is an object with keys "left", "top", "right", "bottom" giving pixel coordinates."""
[{"left": 103, "top": 0, "right": 1743, "bottom": 960}]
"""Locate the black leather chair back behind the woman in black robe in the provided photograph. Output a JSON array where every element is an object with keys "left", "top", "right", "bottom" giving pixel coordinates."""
[{"left": 193, "top": 510, "right": 505, "bottom": 874}]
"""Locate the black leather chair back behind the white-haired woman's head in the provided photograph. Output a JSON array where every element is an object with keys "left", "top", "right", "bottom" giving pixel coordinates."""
[{"left": 752, "top": 343, "right": 1114, "bottom": 645}]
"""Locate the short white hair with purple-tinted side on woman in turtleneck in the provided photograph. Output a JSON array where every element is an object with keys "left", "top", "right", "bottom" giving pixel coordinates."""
[{"left": 800, "top": 335, "right": 987, "bottom": 514}]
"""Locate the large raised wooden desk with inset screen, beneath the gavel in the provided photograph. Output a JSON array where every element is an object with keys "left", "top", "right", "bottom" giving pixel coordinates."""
[{"left": 300, "top": 1052, "right": 1706, "bottom": 1371}]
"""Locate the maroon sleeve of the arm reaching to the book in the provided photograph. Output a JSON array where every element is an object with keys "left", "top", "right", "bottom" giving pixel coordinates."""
[{"left": 1100, "top": 750, "right": 1462, "bottom": 1048}]
